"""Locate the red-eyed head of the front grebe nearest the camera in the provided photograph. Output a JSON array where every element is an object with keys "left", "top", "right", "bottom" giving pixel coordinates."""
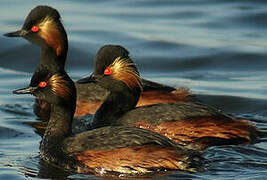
[{"left": 13, "top": 69, "right": 76, "bottom": 105}]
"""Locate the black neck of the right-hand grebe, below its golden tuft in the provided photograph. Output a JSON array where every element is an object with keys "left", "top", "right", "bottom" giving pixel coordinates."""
[{"left": 92, "top": 88, "right": 140, "bottom": 128}]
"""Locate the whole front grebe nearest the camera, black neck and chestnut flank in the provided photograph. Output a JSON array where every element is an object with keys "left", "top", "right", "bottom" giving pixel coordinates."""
[{"left": 14, "top": 66, "right": 201, "bottom": 174}]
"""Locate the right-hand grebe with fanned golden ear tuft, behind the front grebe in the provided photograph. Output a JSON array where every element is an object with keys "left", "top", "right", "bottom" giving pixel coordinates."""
[{"left": 79, "top": 57, "right": 260, "bottom": 149}]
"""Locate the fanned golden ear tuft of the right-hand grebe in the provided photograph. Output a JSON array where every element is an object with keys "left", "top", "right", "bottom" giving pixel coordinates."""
[{"left": 108, "top": 57, "right": 143, "bottom": 91}]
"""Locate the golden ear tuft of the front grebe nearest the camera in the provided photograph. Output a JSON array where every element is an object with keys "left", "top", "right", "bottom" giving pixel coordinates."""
[{"left": 48, "top": 74, "right": 71, "bottom": 98}]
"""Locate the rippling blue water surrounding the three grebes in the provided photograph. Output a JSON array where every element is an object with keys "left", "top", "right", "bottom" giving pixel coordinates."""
[{"left": 0, "top": 0, "right": 267, "bottom": 179}]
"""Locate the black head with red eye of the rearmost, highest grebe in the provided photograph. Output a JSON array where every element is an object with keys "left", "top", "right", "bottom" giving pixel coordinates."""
[{"left": 4, "top": 6, "right": 68, "bottom": 56}]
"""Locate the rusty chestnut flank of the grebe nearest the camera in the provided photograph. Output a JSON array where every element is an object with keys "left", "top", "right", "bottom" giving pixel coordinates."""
[{"left": 75, "top": 145, "right": 199, "bottom": 174}]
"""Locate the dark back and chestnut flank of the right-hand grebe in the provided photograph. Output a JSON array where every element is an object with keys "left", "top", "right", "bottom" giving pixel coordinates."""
[{"left": 118, "top": 102, "right": 259, "bottom": 149}]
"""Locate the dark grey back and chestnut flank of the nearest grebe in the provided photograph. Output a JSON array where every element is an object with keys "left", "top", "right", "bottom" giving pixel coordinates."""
[{"left": 63, "top": 126, "right": 200, "bottom": 173}]
